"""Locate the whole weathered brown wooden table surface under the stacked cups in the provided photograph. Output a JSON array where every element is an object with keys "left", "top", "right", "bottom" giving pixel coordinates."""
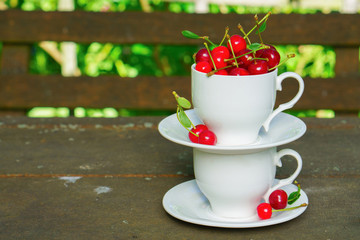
[{"left": 0, "top": 117, "right": 360, "bottom": 240}]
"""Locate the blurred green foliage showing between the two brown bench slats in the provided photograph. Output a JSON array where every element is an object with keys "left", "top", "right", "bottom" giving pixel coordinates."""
[{"left": 30, "top": 42, "right": 335, "bottom": 78}]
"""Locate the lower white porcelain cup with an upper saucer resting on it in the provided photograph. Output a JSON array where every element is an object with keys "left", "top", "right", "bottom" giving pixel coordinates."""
[{"left": 194, "top": 147, "right": 302, "bottom": 220}]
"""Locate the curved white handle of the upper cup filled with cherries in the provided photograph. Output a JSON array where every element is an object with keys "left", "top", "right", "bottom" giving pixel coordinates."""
[{"left": 263, "top": 72, "right": 304, "bottom": 132}]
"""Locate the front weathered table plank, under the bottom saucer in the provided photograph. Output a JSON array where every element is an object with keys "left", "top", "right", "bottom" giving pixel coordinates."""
[{"left": 0, "top": 171, "right": 360, "bottom": 240}]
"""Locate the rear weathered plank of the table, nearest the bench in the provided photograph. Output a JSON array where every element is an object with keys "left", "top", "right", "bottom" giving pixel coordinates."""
[{"left": 0, "top": 116, "right": 360, "bottom": 177}]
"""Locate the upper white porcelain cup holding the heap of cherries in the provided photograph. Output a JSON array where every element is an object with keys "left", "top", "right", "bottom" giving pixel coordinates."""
[{"left": 191, "top": 65, "right": 304, "bottom": 146}]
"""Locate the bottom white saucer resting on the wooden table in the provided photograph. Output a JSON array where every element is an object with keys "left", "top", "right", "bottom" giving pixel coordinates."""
[{"left": 163, "top": 180, "right": 309, "bottom": 228}]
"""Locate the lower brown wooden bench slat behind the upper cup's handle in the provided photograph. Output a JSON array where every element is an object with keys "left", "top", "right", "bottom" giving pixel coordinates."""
[{"left": 0, "top": 75, "right": 360, "bottom": 110}]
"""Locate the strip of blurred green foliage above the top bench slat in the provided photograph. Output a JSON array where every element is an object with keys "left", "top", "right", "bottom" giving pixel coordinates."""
[{"left": 5, "top": 0, "right": 341, "bottom": 14}]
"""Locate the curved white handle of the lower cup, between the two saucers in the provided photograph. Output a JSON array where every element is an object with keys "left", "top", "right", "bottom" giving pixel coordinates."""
[{"left": 264, "top": 149, "right": 302, "bottom": 202}]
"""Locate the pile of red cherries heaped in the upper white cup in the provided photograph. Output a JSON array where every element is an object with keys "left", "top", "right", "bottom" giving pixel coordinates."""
[{"left": 194, "top": 34, "right": 280, "bottom": 76}]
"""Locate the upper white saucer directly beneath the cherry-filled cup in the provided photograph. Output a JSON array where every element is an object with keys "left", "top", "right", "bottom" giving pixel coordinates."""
[{"left": 158, "top": 109, "right": 306, "bottom": 153}]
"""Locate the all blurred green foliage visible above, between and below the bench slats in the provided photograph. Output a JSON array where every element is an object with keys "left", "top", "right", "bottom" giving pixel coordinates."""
[{"left": 0, "top": 0, "right": 348, "bottom": 117}]
